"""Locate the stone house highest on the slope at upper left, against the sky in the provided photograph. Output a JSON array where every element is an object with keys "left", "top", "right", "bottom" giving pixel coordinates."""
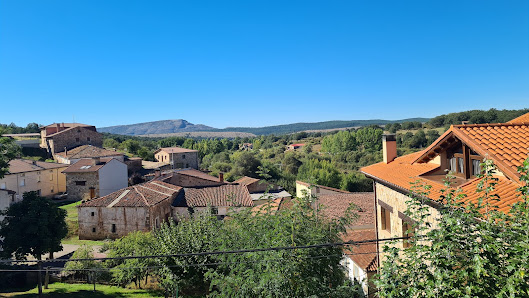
[{"left": 40, "top": 123, "right": 103, "bottom": 156}]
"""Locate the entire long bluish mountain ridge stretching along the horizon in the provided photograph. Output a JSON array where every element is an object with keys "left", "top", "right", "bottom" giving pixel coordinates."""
[{"left": 97, "top": 118, "right": 430, "bottom": 136}]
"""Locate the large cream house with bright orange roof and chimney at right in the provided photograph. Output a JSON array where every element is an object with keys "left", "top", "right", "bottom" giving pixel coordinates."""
[{"left": 361, "top": 114, "right": 529, "bottom": 272}]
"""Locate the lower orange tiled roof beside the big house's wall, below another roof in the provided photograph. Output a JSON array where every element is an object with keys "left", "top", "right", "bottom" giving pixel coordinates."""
[{"left": 342, "top": 229, "right": 378, "bottom": 272}]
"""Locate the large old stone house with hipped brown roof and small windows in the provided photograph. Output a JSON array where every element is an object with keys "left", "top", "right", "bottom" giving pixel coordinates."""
[{"left": 78, "top": 181, "right": 182, "bottom": 240}]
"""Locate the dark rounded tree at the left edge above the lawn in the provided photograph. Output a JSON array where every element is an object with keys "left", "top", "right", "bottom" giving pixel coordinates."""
[{"left": 0, "top": 191, "right": 68, "bottom": 260}]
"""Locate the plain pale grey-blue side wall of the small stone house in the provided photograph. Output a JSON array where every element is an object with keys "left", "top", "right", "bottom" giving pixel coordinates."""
[{"left": 98, "top": 159, "right": 128, "bottom": 197}]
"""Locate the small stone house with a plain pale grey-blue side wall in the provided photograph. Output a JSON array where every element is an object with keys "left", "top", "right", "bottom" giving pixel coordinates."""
[{"left": 63, "top": 157, "right": 128, "bottom": 200}]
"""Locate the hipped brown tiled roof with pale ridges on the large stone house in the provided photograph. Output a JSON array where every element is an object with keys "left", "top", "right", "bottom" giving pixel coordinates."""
[{"left": 79, "top": 181, "right": 182, "bottom": 208}]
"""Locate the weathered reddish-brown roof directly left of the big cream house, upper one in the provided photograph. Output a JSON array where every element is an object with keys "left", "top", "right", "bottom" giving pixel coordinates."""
[{"left": 318, "top": 192, "right": 375, "bottom": 226}]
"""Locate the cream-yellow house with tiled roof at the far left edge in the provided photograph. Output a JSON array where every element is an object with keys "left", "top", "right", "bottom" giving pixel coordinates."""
[{"left": 0, "top": 159, "right": 68, "bottom": 199}]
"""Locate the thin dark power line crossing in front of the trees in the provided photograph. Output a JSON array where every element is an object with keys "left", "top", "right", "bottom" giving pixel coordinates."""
[{"left": 0, "top": 237, "right": 411, "bottom": 263}]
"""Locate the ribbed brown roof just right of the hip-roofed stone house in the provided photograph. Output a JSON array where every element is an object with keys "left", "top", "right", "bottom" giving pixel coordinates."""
[{"left": 173, "top": 185, "right": 253, "bottom": 207}]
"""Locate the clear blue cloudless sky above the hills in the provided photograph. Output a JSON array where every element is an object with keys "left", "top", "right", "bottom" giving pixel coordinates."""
[{"left": 0, "top": 0, "right": 529, "bottom": 128}]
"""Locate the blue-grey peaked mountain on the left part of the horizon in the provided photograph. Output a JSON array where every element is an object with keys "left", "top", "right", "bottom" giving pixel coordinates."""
[{"left": 97, "top": 119, "right": 215, "bottom": 136}]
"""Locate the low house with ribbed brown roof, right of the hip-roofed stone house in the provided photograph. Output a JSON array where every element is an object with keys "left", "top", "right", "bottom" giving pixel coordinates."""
[{"left": 172, "top": 184, "right": 254, "bottom": 220}]
